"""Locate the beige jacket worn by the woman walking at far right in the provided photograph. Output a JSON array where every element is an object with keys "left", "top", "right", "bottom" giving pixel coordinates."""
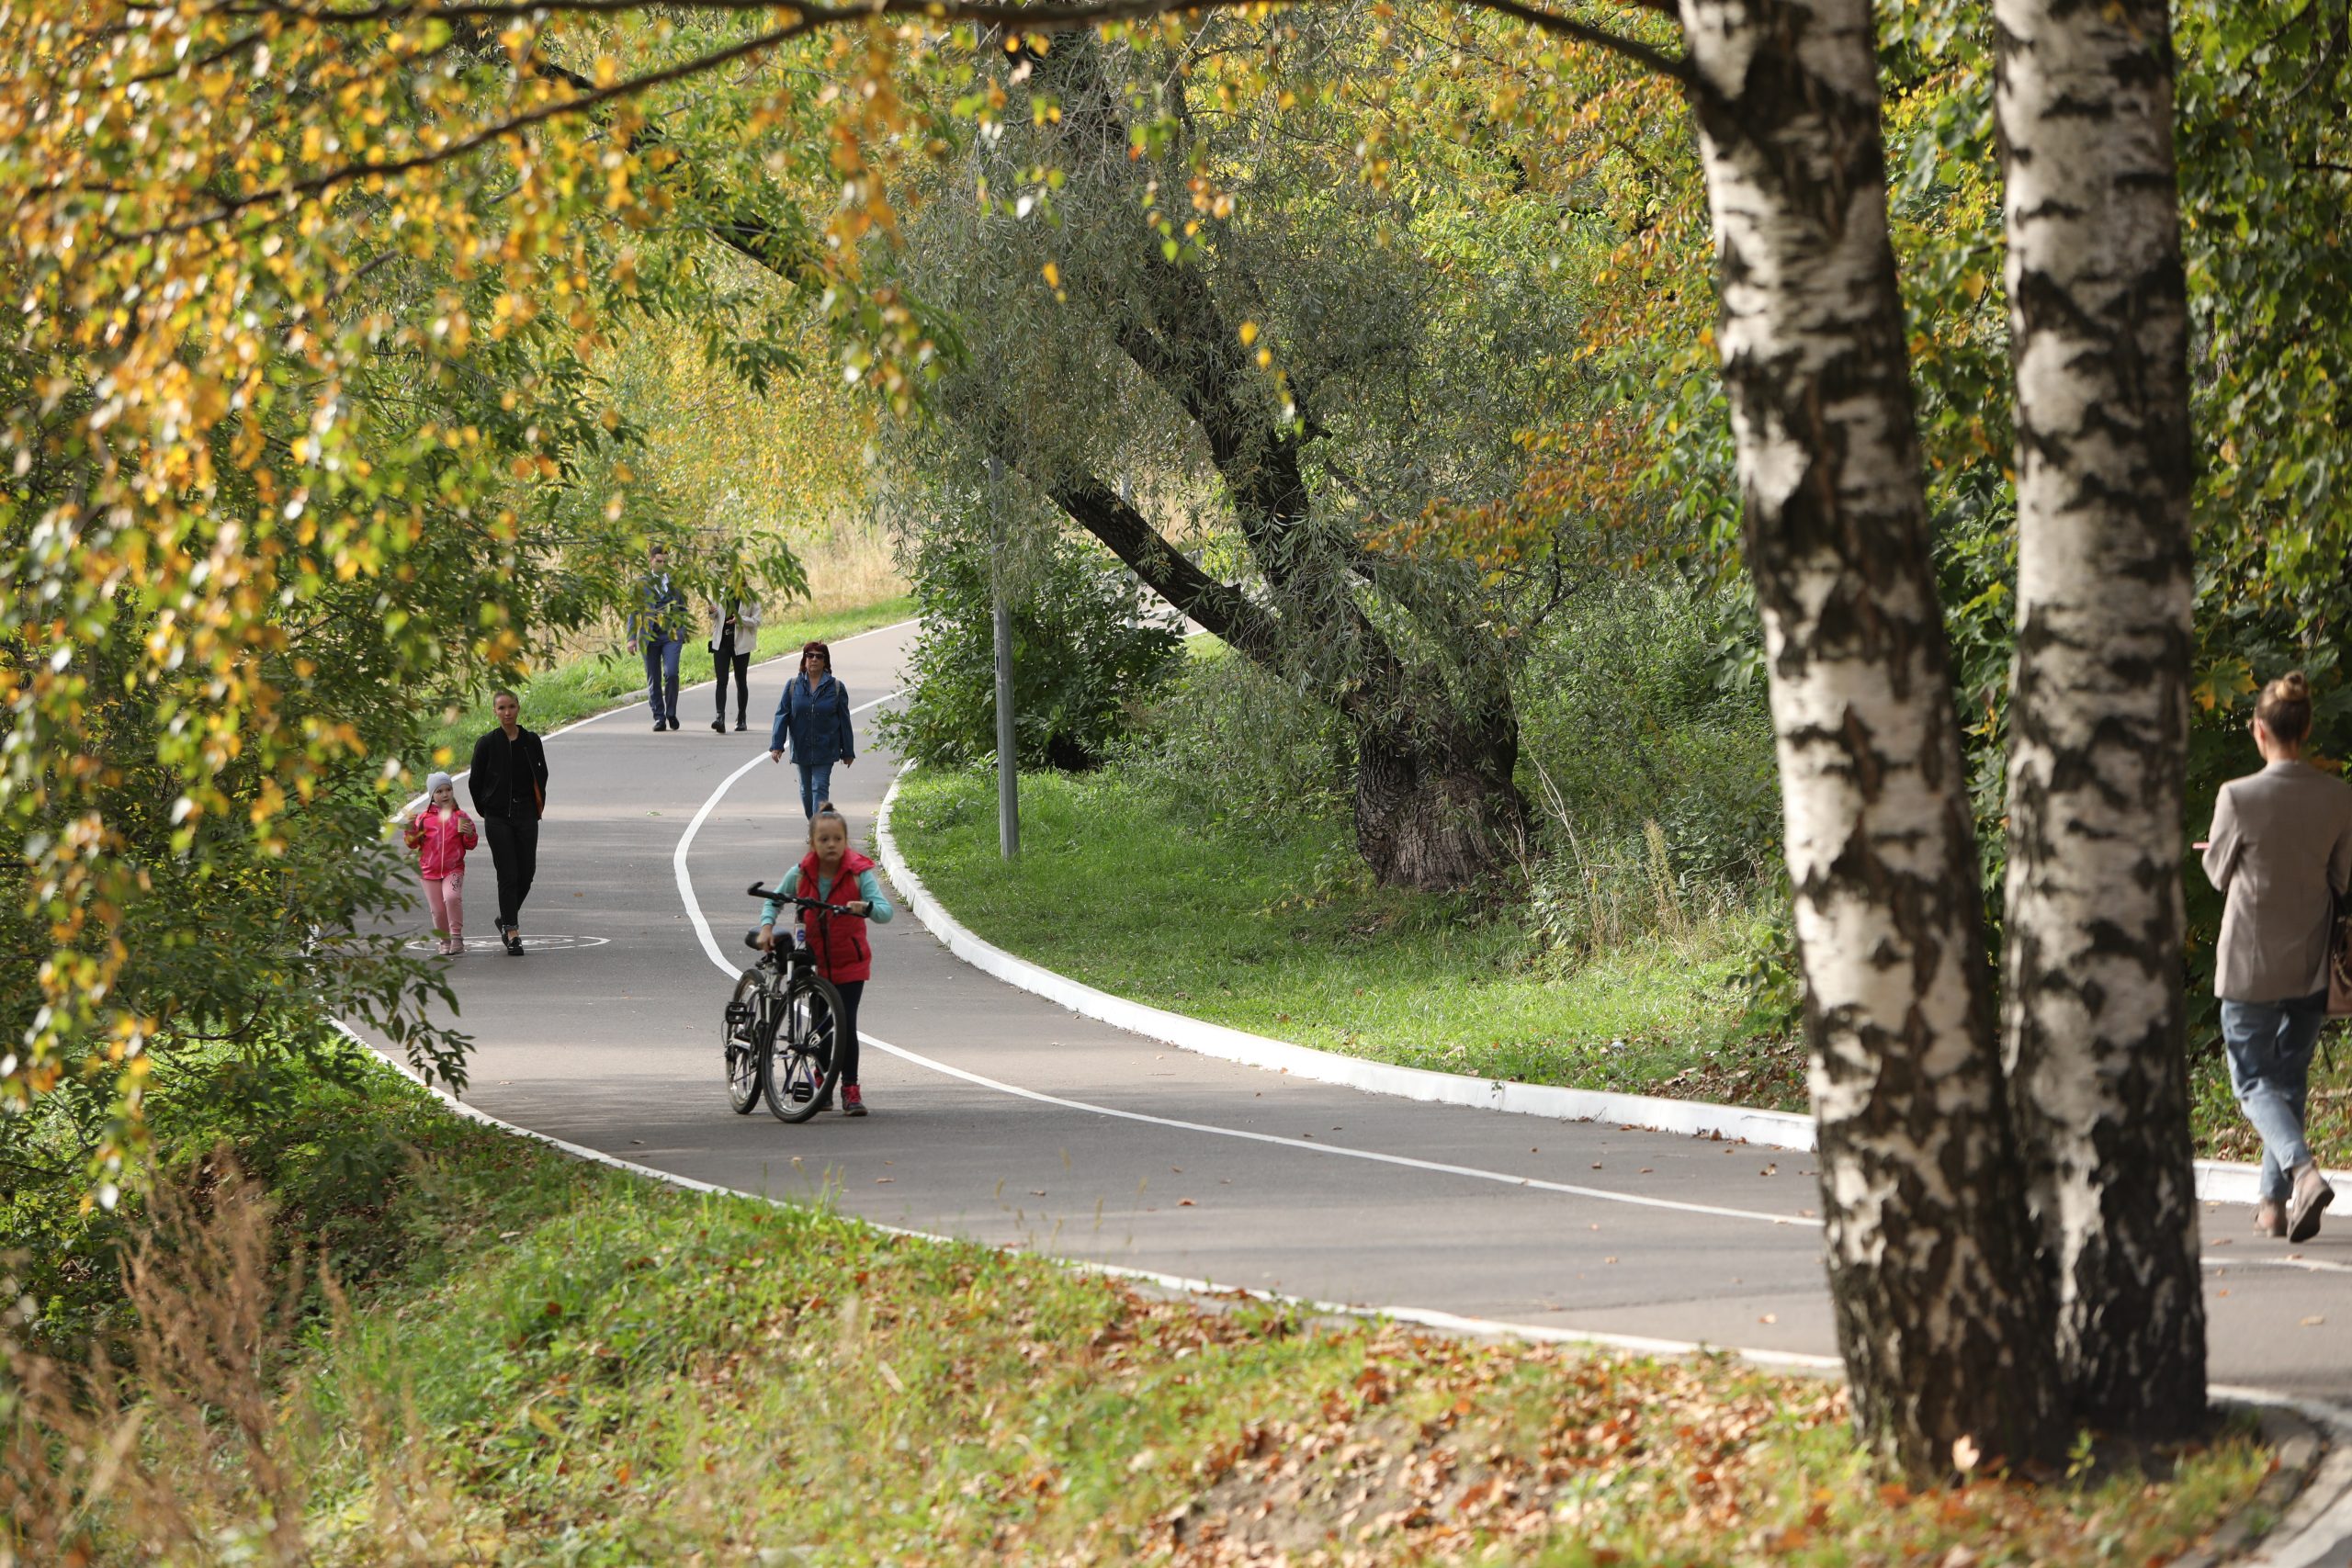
[{"left": 2206, "top": 761, "right": 2352, "bottom": 1001}]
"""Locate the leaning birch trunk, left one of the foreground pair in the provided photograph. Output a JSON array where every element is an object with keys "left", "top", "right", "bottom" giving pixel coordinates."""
[{"left": 1681, "top": 0, "right": 2065, "bottom": 1476}]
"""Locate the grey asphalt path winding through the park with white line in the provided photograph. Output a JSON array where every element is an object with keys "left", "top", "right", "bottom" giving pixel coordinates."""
[{"left": 357, "top": 626, "right": 2352, "bottom": 1401}]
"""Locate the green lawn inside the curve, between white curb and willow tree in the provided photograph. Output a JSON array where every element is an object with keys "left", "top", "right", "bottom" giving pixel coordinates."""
[{"left": 891, "top": 769, "right": 1804, "bottom": 1110}]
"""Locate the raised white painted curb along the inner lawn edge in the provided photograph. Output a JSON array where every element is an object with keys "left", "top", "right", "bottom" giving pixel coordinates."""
[{"left": 875, "top": 761, "right": 2295, "bottom": 1203}]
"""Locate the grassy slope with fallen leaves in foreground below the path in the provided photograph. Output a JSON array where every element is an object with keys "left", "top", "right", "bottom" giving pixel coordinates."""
[{"left": 0, "top": 1034, "right": 2267, "bottom": 1563}]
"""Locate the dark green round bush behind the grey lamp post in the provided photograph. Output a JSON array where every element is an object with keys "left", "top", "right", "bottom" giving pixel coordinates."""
[{"left": 879, "top": 534, "right": 1183, "bottom": 771}]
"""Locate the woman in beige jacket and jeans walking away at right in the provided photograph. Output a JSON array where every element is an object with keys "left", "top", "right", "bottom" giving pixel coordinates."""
[{"left": 2204, "top": 672, "right": 2352, "bottom": 1241}]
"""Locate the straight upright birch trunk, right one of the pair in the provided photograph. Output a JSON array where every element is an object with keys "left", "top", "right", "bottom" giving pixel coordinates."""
[{"left": 1992, "top": 0, "right": 2206, "bottom": 1438}]
